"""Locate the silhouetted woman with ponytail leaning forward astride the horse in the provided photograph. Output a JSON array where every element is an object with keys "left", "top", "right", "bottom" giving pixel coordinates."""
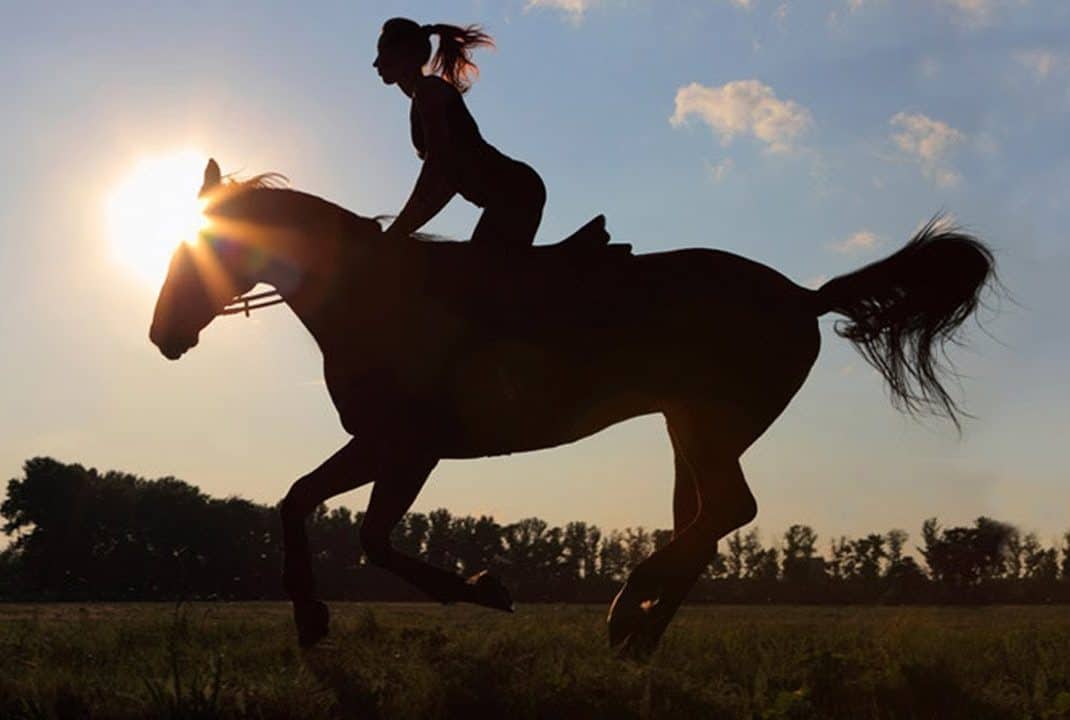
[{"left": 372, "top": 17, "right": 546, "bottom": 248}]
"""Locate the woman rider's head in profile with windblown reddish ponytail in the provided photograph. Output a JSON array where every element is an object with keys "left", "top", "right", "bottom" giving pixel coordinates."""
[{"left": 372, "top": 17, "right": 494, "bottom": 92}]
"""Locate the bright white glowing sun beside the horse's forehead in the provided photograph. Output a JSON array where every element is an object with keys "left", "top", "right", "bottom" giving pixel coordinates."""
[{"left": 107, "top": 150, "right": 208, "bottom": 285}]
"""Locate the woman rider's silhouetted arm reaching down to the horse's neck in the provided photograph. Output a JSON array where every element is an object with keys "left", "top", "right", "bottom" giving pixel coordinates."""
[{"left": 387, "top": 78, "right": 458, "bottom": 235}]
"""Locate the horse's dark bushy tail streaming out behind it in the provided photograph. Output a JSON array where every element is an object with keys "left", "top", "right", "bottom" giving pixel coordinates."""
[{"left": 814, "top": 215, "right": 995, "bottom": 427}]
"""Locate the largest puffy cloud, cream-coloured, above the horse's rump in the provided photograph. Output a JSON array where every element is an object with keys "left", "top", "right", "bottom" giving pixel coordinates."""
[{"left": 670, "top": 80, "right": 812, "bottom": 153}]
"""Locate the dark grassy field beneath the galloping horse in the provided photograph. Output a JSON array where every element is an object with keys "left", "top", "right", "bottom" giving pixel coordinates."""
[{"left": 0, "top": 603, "right": 1070, "bottom": 720}]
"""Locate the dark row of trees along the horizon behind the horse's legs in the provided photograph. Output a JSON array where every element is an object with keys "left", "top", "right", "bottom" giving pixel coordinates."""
[{"left": 6, "top": 458, "right": 1070, "bottom": 603}]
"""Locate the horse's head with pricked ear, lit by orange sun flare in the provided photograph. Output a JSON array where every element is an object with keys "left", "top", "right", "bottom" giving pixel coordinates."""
[{"left": 149, "top": 159, "right": 276, "bottom": 359}]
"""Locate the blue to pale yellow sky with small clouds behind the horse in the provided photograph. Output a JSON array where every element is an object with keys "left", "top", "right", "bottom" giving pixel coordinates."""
[{"left": 0, "top": 0, "right": 1070, "bottom": 548}]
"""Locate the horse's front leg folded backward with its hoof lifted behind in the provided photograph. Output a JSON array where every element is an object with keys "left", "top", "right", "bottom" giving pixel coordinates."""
[{"left": 361, "top": 450, "right": 513, "bottom": 612}]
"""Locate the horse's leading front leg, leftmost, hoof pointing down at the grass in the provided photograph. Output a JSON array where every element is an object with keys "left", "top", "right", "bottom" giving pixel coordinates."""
[{"left": 280, "top": 440, "right": 380, "bottom": 647}]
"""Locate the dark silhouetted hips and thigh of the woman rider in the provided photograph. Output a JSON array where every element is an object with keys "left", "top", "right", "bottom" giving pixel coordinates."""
[{"left": 472, "top": 163, "right": 546, "bottom": 249}]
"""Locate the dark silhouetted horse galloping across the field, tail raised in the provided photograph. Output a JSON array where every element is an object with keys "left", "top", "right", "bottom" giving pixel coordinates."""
[{"left": 149, "top": 160, "right": 995, "bottom": 656}]
